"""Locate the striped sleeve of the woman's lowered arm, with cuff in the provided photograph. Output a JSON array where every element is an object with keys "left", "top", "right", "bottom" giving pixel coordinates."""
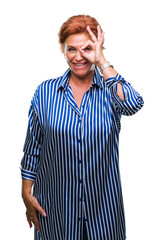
[{"left": 20, "top": 87, "right": 44, "bottom": 181}]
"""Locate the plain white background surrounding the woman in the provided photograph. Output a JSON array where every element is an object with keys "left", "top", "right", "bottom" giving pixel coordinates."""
[{"left": 0, "top": 0, "right": 163, "bottom": 240}]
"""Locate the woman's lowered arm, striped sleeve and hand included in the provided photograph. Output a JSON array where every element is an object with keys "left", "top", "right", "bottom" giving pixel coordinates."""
[{"left": 21, "top": 87, "right": 46, "bottom": 232}]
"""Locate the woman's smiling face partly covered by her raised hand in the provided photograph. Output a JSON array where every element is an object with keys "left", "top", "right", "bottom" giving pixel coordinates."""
[{"left": 64, "top": 33, "right": 95, "bottom": 78}]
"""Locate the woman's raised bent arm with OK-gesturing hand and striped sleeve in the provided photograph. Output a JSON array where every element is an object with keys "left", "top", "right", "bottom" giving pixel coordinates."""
[{"left": 80, "top": 26, "right": 144, "bottom": 115}]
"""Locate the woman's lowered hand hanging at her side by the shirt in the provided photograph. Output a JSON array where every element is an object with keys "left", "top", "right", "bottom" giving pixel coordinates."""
[{"left": 22, "top": 193, "right": 46, "bottom": 232}]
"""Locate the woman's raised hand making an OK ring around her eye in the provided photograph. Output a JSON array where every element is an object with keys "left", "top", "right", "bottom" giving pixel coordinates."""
[{"left": 80, "top": 26, "right": 107, "bottom": 68}]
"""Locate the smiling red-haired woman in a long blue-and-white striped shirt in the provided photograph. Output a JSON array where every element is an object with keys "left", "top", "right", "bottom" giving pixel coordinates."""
[{"left": 21, "top": 15, "right": 143, "bottom": 240}]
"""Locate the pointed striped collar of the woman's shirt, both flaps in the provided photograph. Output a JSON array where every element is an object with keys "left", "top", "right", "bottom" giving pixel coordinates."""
[{"left": 57, "top": 67, "right": 103, "bottom": 90}]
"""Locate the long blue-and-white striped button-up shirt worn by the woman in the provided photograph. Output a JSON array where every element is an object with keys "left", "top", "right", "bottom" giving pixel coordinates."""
[{"left": 21, "top": 67, "right": 143, "bottom": 240}]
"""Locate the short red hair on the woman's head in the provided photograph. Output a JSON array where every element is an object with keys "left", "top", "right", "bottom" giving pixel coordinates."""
[{"left": 58, "top": 15, "right": 99, "bottom": 52}]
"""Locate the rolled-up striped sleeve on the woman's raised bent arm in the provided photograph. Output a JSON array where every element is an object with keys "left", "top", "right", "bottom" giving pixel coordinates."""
[{"left": 106, "top": 74, "right": 144, "bottom": 116}]
